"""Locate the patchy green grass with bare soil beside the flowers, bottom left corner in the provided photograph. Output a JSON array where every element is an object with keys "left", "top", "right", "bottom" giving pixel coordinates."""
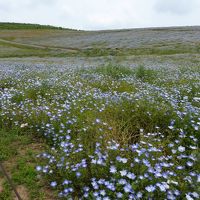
[{"left": 0, "top": 129, "right": 54, "bottom": 200}]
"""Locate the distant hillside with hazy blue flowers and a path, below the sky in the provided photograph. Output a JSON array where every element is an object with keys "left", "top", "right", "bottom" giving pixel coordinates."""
[{"left": 0, "top": 24, "right": 200, "bottom": 57}]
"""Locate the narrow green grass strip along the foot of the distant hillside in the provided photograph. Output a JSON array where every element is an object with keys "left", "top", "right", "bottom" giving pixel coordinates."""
[{"left": 0, "top": 41, "right": 200, "bottom": 58}]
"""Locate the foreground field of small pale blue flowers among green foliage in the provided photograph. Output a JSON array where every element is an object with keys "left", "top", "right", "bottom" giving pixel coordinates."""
[{"left": 0, "top": 65, "right": 200, "bottom": 200}]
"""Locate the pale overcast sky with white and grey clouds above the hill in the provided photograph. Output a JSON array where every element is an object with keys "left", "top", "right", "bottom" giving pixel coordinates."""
[{"left": 0, "top": 0, "right": 200, "bottom": 30}]
